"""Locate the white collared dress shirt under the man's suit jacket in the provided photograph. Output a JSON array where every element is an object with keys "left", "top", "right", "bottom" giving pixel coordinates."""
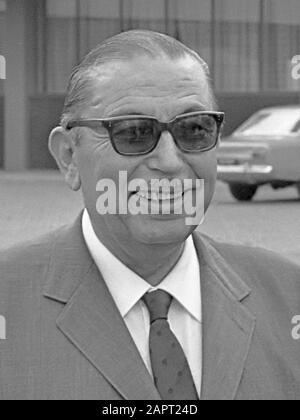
[{"left": 82, "top": 210, "right": 202, "bottom": 397}]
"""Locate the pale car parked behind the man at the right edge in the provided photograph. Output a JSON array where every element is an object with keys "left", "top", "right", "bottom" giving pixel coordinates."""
[{"left": 218, "top": 105, "right": 300, "bottom": 201}]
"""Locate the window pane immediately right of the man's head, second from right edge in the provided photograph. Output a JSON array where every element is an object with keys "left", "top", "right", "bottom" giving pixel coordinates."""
[{"left": 213, "top": 0, "right": 260, "bottom": 92}]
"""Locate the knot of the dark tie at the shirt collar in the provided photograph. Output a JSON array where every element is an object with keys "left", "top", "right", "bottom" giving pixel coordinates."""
[{"left": 143, "top": 290, "right": 172, "bottom": 324}]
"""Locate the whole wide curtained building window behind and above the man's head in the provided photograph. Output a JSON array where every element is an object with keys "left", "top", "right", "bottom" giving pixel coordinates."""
[{"left": 43, "top": 0, "right": 300, "bottom": 93}]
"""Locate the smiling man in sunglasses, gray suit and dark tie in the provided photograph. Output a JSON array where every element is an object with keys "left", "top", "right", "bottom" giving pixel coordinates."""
[{"left": 0, "top": 31, "right": 300, "bottom": 400}]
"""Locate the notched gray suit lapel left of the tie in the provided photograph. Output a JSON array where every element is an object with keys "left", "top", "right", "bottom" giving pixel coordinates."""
[{"left": 44, "top": 218, "right": 160, "bottom": 400}]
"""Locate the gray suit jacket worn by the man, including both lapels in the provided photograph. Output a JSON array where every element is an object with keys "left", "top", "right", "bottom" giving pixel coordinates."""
[{"left": 0, "top": 218, "right": 300, "bottom": 400}]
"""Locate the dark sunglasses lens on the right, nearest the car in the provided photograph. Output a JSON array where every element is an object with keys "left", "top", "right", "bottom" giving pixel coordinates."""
[{"left": 173, "top": 114, "right": 218, "bottom": 152}]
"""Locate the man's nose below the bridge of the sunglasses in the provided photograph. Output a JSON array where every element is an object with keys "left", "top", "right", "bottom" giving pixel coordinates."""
[{"left": 148, "top": 131, "right": 184, "bottom": 175}]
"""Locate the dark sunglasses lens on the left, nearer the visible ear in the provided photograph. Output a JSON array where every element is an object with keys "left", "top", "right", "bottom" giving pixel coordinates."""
[{"left": 111, "top": 119, "right": 157, "bottom": 155}]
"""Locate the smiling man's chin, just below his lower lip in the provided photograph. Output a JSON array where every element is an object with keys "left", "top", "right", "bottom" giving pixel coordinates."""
[{"left": 127, "top": 216, "right": 197, "bottom": 245}]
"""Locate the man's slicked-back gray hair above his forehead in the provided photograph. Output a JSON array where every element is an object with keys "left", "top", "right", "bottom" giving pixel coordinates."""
[{"left": 60, "top": 30, "right": 216, "bottom": 128}]
